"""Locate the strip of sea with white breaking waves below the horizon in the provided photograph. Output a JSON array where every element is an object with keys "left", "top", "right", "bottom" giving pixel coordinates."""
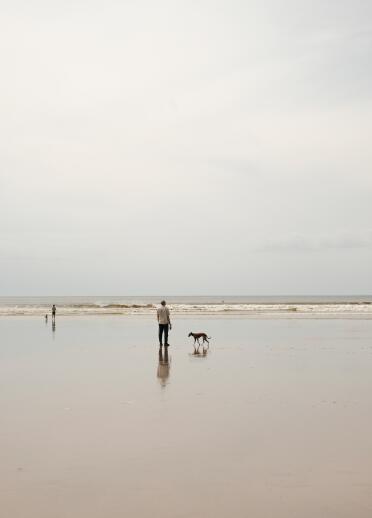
[{"left": 0, "top": 295, "right": 372, "bottom": 318}]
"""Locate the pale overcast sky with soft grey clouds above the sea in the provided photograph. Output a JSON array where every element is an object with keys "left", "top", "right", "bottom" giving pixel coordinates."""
[{"left": 0, "top": 0, "right": 372, "bottom": 295}]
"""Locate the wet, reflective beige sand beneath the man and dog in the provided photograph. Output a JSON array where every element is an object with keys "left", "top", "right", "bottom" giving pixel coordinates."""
[{"left": 0, "top": 316, "right": 372, "bottom": 518}]
